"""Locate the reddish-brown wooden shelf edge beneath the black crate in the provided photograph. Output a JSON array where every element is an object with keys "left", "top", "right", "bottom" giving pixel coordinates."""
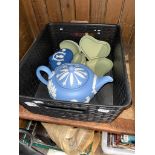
[{"left": 19, "top": 105, "right": 135, "bottom": 134}]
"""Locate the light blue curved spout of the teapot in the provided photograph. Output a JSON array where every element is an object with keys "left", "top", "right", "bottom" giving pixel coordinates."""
[{"left": 96, "top": 76, "right": 113, "bottom": 91}]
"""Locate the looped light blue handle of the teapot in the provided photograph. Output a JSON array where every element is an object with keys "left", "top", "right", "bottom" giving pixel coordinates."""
[{"left": 36, "top": 66, "right": 52, "bottom": 85}]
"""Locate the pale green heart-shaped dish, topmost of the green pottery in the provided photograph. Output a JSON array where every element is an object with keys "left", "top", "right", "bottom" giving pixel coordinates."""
[{"left": 79, "top": 34, "right": 111, "bottom": 60}]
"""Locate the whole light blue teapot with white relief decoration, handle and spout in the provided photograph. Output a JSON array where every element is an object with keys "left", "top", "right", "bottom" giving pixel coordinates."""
[{"left": 36, "top": 63, "right": 113, "bottom": 103}]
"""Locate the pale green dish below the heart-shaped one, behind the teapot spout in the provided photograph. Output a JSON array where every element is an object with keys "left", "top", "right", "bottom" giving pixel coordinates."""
[{"left": 86, "top": 58, "right": 113, "bottom": 76}]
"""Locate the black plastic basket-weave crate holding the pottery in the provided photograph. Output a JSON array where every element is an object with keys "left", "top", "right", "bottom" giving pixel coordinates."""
[{"left": 19, "top": 23, "right": 131, "bottom": 122}]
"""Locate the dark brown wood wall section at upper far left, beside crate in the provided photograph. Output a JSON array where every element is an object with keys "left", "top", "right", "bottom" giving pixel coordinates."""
[{"left": 19, "top": 1, "right": 34, "bottom": 59}]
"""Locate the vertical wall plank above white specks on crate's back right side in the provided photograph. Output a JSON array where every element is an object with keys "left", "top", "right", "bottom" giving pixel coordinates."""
[{"left": 90, "top": 0, "right": 107, "bottom": 23}]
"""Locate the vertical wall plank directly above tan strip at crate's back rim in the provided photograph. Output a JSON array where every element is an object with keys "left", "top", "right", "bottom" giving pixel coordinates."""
[{"left": 75, "top": 0, "right": 90, "bottom": 21}]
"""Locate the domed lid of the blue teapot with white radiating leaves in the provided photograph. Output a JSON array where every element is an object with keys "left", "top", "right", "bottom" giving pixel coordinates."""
[{"left": 55, "top": 63, "right": 89, "bottom": 89}]
